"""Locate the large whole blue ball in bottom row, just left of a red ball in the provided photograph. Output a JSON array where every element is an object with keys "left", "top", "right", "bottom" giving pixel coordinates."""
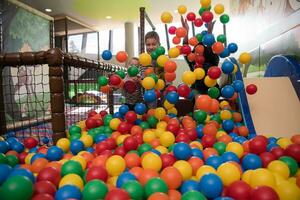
[{"left": 199, "top": 174, "right": 223, "bottom": 199}]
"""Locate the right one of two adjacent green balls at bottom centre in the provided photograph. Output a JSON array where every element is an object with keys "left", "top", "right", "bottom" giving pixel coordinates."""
[{"left": 145, "top": 178, "right": 168, "bottom": 197}]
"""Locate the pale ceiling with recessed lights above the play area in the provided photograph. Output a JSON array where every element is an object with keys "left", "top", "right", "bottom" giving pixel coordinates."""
[{"left": 20, "top": 0, "right": 229, "bottom": 31}]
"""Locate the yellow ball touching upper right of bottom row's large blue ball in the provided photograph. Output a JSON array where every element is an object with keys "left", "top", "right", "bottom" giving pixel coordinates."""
[{"left": 217, "top": 163, "right": 241, "bottom": 186}]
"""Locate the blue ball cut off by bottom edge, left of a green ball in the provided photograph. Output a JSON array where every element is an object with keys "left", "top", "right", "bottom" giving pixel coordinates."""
[{"left": 55, "top": 185, "right": 81, "bottom": 200}]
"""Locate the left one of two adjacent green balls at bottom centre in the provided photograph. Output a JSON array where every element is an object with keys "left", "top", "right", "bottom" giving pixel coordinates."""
[{"left": 122, "top": 180, "right": 144, "bottom": 199}]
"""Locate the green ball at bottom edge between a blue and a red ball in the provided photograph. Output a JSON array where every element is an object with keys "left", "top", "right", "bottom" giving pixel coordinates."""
[{"left": 82, "top": 180, "right": 108, "bottom": 199}]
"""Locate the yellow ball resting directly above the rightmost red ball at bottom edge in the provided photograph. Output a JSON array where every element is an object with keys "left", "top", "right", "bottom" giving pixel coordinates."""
[{"left": 250, "top": 168, "right": 276, "bottom": 189}]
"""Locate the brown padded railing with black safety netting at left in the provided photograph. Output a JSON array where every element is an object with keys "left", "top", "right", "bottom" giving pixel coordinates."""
[{"left": 0, "top": 49, "right": 122, "bottom": 142}]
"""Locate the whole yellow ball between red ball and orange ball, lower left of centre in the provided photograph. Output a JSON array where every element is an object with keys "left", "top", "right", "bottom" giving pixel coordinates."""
[{"left": 105, "top": 155, "right": 126, "bottom": 176}]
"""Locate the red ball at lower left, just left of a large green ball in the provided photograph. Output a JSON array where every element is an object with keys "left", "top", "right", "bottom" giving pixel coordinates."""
[{"left": 36, "top": 167, "right": 61, "bottom": 186}]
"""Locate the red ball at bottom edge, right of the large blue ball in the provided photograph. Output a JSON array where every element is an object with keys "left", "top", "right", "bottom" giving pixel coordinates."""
[{"left": 226, "top": 181, "right": 252, "bottom": 200}]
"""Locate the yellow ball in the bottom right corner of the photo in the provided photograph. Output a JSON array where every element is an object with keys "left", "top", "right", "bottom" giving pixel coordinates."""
[{"left": 276, "top": 180, "right": 300, "bottom": 200}]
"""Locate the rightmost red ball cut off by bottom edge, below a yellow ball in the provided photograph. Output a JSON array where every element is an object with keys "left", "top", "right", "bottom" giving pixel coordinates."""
[{"left": 250, "top": 186, "right": 279, "bottom": 200}]
